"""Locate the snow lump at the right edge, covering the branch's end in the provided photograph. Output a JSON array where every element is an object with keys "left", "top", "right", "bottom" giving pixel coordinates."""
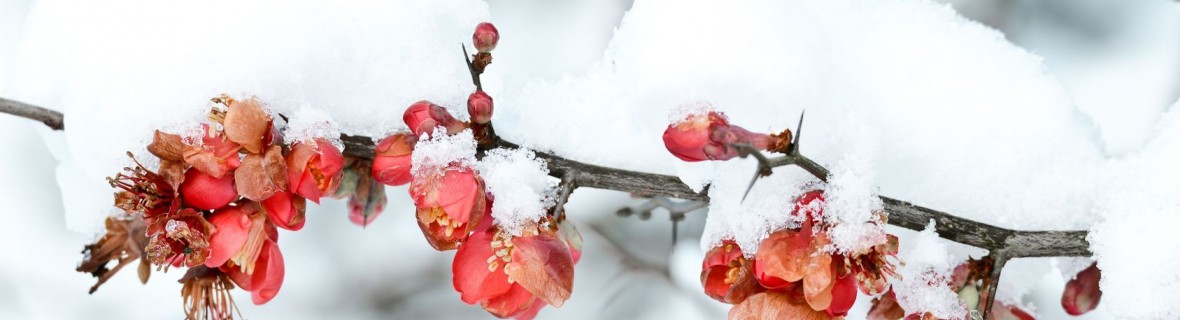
[{"left": 1089, "top": 104, "right": 1180, "bottom": 319}]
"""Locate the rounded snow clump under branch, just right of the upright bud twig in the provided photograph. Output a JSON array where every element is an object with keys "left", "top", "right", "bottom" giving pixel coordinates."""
[{"left": 478, "top": 149, "right": 557, "bottom": 235}]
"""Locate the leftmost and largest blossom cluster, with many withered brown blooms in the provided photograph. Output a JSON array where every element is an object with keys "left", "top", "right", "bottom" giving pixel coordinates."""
[{"left": 79, "top": 97, "right": 348, "bottom": 319}]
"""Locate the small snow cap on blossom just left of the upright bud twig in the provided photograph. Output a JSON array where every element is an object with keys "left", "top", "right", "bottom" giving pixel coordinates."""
[{"left": 409, "top": 128, "right": 476, "bottom": 177}]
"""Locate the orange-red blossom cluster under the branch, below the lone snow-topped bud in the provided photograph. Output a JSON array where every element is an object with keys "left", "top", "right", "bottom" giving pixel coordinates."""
[{"left": 701, "top": 190, "right": 897, "bottom": 319}]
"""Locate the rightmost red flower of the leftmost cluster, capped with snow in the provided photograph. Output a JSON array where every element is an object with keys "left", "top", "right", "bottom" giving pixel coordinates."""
[{"left": 287, "top": 138, "right": 345, "bottom": 203}]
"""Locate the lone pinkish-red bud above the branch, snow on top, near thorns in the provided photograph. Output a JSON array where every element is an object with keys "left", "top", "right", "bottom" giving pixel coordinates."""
[{"left": 663, "top": 111, "right": 789, "bottom": 162}]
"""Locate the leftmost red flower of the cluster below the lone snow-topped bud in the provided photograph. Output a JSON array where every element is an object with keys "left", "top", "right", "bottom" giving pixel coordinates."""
[{"left": 701, "top": 240, "right": 761, "bottom": 305}]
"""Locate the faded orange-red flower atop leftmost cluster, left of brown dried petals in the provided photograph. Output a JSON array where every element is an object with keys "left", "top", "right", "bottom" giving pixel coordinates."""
[{"left": 184, "top": 124, "right": 242, "bottom": 178}]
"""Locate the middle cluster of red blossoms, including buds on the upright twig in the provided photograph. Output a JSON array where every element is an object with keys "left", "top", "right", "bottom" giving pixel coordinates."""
[{"left": 371, "top": 22, "right": 582, "bottom": 319}]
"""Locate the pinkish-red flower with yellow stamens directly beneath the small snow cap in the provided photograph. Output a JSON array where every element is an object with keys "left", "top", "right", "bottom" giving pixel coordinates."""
[{"left": 409, "top": 165, "right": 486, "bottom": 250}]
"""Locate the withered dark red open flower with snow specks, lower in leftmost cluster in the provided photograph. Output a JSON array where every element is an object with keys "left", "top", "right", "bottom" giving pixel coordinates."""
[{"left": 145, "top": 209, "right": 216, "bottom": 267}]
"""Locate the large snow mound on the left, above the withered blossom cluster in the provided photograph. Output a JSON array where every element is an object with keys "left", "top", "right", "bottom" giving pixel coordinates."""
[{"left": 4, "top": 0, "right": 488, "bottom": 231}]
